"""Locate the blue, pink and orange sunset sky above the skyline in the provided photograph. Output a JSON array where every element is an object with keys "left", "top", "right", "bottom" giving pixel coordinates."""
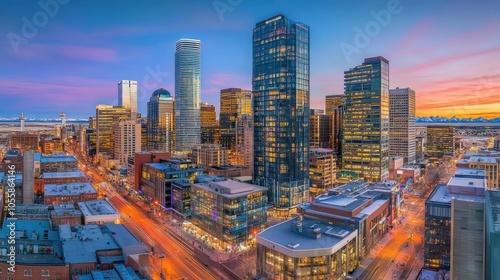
[{"left": 0, "top": 0, "right": 500, "bottom": 118}]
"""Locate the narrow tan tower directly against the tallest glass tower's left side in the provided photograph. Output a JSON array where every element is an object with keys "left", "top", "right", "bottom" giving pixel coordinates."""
[{"left": 236, "top": 115, "right": 253, "bottom": 170}]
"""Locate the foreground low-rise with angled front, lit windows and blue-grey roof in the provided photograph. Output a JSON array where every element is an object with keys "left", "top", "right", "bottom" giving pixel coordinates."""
[{"left": 257, "top": 216, "right": 359, "bottom": 280}]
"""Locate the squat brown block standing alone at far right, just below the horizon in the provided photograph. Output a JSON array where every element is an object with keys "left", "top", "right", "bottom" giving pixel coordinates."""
[{"left": 425, "top": 126, "right": 455, "bottom": 158}]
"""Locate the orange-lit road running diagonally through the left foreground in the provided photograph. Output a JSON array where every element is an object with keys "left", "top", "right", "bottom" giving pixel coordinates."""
[{"left": 72, "top": 150, "right": 221, "bottom": 280}]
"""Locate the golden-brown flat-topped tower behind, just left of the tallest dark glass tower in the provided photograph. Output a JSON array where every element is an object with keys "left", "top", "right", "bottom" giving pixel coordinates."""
[{"left": 219, "top": 88, "right": 252, "bottom": 131}]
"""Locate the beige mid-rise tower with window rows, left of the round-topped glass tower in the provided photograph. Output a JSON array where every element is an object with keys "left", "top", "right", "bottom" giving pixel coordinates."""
[{"left": 114, "top": 120, "right": 141, "bottom": 166}]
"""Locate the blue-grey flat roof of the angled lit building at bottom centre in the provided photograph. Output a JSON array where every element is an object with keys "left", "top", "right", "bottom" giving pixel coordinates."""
[{"left": 257, "top": 218, "right": 357, "bottom": 255}]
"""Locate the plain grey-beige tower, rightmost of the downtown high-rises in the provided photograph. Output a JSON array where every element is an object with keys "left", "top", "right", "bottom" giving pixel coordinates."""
[{"left": 389, "top": 88, "right": 417, "bottom": 164}]
